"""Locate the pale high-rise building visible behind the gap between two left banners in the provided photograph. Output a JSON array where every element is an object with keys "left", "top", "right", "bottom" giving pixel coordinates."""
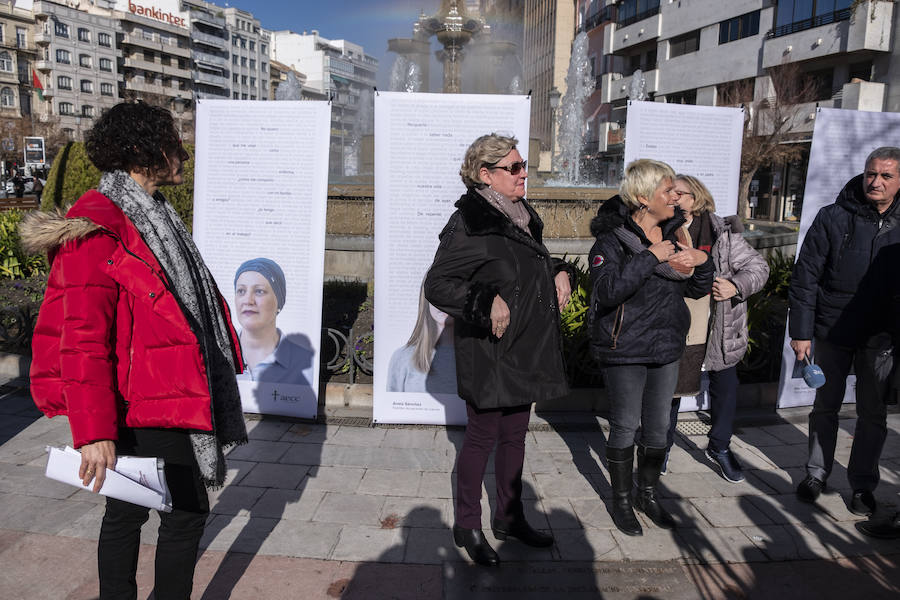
[{"left": 272, "top": 30, "right": 378, "bottom": 176}]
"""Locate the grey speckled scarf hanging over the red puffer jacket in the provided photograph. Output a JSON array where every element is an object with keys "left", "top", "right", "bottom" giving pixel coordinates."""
[{"left": 97, "top": 171, "right": 247, "bottom": 487}]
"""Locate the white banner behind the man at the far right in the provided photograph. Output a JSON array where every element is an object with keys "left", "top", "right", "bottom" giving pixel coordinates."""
[{"left": 778, "top": 108, "right": 900, "bottom": 408}]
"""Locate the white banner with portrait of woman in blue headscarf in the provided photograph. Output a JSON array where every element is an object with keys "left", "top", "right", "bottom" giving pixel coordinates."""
[{"left": 194, "top": 100, "right": 331, "bottom": 418}]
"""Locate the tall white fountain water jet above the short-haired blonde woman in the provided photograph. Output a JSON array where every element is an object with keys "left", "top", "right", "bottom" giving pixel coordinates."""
[{"left": 548, "top": 32, "right": 594, "bottom": 186}]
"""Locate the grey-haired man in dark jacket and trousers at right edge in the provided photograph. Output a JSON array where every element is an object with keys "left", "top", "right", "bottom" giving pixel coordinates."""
[{"left": 789, "top": 147, "right": 900, "bottom": 515}]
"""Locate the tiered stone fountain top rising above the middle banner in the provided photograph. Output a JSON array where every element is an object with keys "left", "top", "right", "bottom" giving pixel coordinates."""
[{"left": 388, "top": 0, "right": 516, "bottom": 94}]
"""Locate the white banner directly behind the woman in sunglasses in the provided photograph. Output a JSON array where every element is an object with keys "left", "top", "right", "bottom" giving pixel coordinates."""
[{"left": 372, "top": 92, "right": 531, "bottom": 425}]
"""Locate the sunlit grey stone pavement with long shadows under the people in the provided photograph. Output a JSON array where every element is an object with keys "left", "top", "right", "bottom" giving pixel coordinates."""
[{"left": 0, "top": 380, "right": 900, "bottom": 600}]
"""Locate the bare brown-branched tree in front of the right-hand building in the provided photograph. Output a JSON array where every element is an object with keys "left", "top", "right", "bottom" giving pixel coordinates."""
[{"left": 719, "top": 63, "right": 818, "bottom": 217}]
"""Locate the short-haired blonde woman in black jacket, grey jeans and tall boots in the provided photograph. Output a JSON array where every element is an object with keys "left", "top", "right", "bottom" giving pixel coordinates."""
[{"left": 589, "top": 159, "right": 713, "bottom": 535}]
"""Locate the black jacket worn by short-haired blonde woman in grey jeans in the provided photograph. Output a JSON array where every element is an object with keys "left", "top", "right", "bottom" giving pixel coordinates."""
[{"left": 588, "top": 196, "right": 714, "bottom": 365}]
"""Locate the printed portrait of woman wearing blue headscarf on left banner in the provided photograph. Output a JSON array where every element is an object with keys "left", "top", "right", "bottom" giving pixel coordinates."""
[{"left": 234, "top": 258, "right": 312, "bottom": 386}]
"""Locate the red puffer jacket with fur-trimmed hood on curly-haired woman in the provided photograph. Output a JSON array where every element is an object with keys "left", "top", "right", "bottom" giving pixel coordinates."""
[{"left": 20, "top": 190, "right": 243, "bottom": 448}]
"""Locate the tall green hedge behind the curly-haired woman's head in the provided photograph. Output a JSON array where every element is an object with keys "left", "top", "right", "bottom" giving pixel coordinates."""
[{"left": 41, "top": 142, "right": 194, "bottom": 231}]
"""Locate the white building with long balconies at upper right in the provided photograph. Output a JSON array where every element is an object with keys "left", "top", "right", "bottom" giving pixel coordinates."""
[{"left": 595, "top": 0, "right": 900, "bottom": 221}]
